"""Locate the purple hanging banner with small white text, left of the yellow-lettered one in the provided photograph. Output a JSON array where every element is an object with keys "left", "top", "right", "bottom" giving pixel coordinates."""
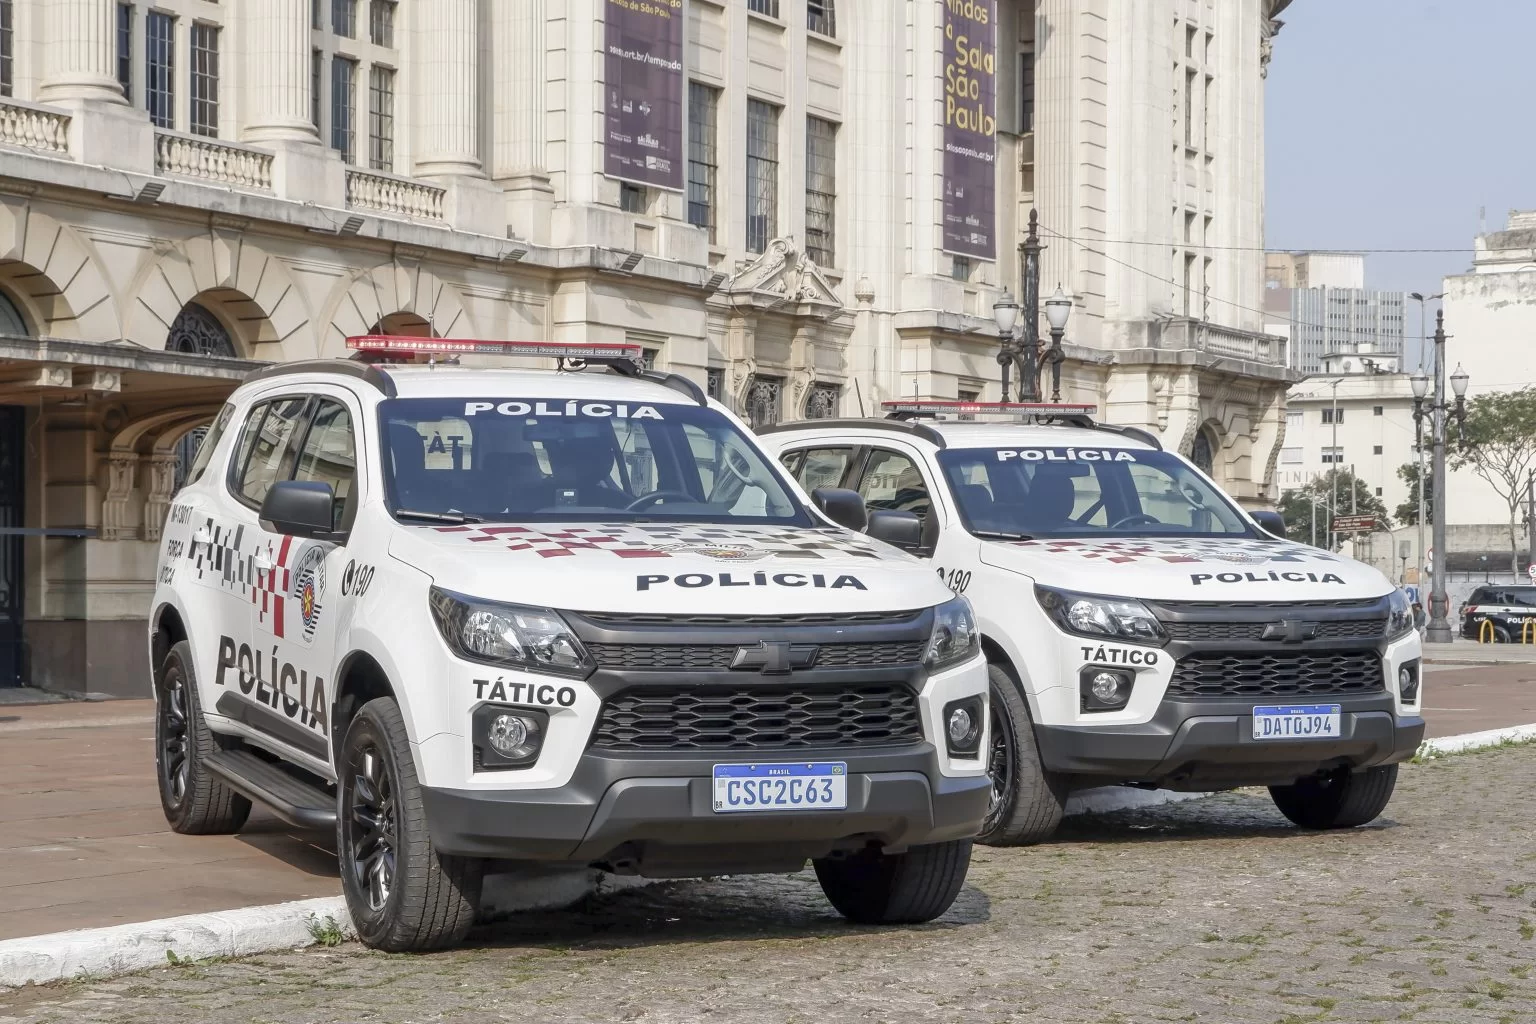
[{"left": 604, "top": 0, "right": 688, "bottom": 192}]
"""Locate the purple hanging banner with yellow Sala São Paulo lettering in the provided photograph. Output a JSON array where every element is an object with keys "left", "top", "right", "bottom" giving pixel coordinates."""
[{"left": 943, "top": 0, "right": 997, "bottom": 259}]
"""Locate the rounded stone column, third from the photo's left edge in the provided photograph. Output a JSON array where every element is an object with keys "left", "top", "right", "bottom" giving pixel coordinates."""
[{"left": 412, "top": 0, "right": 484, "bottom": 178}]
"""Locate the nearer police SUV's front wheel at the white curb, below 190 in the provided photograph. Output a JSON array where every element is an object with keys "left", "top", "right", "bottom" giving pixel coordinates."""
[{"left": 336, "top": 697, "right": 484, "bottom": 953}]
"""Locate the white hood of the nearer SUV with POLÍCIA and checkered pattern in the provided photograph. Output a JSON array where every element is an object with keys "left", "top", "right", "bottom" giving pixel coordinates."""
[{"left": 389, "top": 524, "right": 952, "bottom": 616}]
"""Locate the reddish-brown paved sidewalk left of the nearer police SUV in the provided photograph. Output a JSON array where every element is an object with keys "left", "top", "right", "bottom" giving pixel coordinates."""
[{"left": 0, "top": 700, "right": 341, "bottom": 940}]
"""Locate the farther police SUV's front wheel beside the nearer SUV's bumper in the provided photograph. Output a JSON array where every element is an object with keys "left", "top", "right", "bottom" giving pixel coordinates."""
[{"left": 977, "top": 665, "right": 1066, "bottom": 846}]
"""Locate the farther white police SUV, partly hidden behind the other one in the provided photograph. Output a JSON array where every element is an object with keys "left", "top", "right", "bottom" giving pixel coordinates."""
[{"left": 765, "top": 402, "right": 1424, "bottom": 844}]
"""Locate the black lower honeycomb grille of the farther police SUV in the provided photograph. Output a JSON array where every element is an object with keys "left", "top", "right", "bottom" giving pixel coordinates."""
[{"left": 1167, "top": 651, "right": 1385, "bottom": 700}]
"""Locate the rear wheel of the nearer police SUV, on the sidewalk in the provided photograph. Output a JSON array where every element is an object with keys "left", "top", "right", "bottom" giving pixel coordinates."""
[{"left": 155, "top": 640, "right": 250, "bottom": 835}]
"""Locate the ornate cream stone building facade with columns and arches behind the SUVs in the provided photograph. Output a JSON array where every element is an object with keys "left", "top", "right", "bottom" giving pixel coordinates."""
[{"left": 0, "top": 0, "right": 1293, "bottom": 691}]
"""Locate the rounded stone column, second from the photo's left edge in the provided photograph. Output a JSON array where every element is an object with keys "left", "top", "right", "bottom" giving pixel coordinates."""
[{"left": 240, "top": 0, "right": 319, "bottom": 143}]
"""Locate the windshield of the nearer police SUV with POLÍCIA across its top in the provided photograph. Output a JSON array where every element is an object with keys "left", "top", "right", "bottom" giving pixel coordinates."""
[{"left": 379, "top": 398, "right": 813, "bottom": 525}]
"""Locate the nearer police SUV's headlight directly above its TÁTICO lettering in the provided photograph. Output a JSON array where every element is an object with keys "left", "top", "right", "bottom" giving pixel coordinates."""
[{"left": 430, "top": 586, "right": 594, "bottom": 679}]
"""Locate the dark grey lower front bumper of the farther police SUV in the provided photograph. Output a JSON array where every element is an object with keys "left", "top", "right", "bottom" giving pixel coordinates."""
[{"left": 1035, "top": 692, "right": 1424, "bottom": 792}]
